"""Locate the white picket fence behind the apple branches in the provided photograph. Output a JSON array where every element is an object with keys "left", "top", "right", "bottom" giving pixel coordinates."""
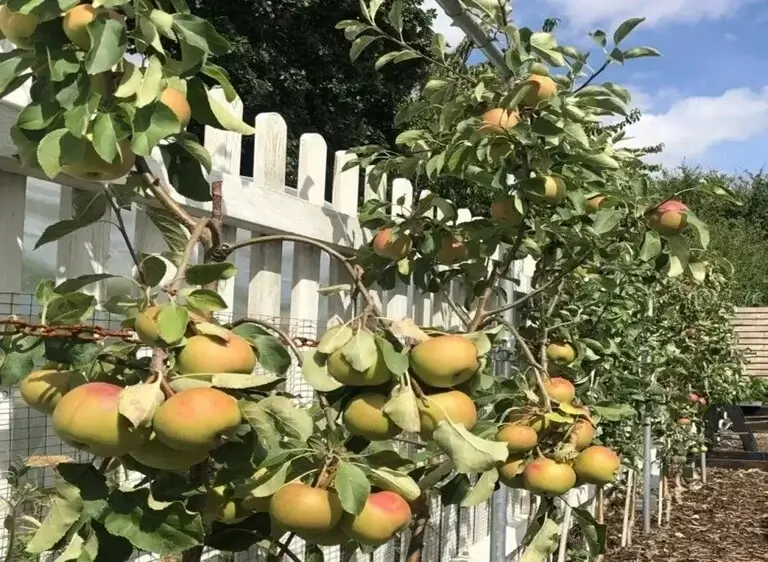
[{"left": 0, "top": 46, "right": 604, "bottom": 562}]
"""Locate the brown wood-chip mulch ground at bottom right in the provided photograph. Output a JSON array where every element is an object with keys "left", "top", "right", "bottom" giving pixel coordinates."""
[{"left": 605, "top": 469, "right": 768, "bottom": 562}]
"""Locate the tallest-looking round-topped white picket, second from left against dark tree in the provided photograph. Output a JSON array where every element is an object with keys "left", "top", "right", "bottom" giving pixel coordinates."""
[{"left": 249, "top": 113, "right": 288, "bottom": 319}]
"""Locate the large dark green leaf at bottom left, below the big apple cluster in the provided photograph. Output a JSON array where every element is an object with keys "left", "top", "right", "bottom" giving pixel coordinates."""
[{"left": 99, "top": 488, "right": 204, "bottom": 556}]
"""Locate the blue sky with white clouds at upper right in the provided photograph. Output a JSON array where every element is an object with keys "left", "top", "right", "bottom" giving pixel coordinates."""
[{"left": 426, "top": 0, "right": 768, "bottom": 172}]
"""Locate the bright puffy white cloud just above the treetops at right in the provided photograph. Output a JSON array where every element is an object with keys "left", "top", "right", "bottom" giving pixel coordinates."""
[{"left": 626, "top": 86, "right": 768, "bottom": 164}]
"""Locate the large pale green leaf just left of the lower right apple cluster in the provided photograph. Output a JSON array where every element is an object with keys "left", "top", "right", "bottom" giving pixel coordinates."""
[{"left": 432, "top": 420, "right": 509, "bottom": 474}]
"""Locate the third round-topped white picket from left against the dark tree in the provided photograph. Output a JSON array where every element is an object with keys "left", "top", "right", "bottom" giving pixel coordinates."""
[{"left": 288, "top": 133, "right": 328, "bottom": 404}]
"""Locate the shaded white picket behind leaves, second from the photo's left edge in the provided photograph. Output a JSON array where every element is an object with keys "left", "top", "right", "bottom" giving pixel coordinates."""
[{"left": 56, "top": 186, "right": 112, "bottom": 300}]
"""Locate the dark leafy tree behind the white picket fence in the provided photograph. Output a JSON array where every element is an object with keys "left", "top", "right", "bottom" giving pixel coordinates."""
[{"left": 192, "top": 0, "right": 435, "bottom": 189}]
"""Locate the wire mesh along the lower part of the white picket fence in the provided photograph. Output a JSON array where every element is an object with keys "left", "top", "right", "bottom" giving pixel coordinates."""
[{"left": 0, "top": 292, "right": 500, "bottom": 562}]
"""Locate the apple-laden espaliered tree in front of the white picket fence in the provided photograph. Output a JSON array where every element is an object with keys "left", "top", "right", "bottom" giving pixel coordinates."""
[{"left": 0, "top": 0, "right": 756, "bottom": 562}]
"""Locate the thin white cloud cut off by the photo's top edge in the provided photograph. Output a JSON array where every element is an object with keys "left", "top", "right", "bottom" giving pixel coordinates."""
[{"left": 546, "top": 0, "right": 754, "bottom": 28}]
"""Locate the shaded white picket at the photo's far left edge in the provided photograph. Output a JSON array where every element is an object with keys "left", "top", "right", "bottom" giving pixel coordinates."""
[{"left": 0, "top": 172, "right": 27, "bottom": 290}]
